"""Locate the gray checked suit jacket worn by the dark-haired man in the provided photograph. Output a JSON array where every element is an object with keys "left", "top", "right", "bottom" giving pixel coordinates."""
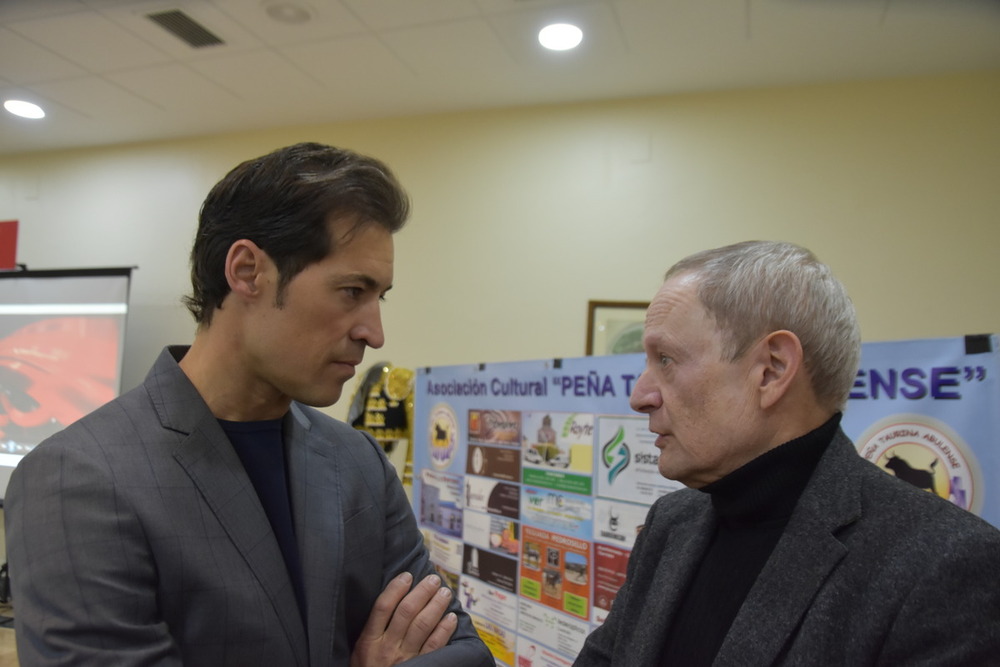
[{"left": 5, "top": 348, "right": 493, "bottom": 667}]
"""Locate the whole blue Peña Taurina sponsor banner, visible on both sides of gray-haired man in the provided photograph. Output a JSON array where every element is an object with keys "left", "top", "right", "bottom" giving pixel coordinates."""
[{"left": 413, "top": 335, "right": 1000, "bottom": 667}]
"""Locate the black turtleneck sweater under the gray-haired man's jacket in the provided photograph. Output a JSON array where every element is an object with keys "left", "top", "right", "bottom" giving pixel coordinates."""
[{"left": 660, "top": 413, "right": 840, "bottom": 667}]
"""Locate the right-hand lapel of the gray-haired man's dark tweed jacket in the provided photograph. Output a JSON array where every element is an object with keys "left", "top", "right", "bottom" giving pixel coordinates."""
[{"left": 713, "top": 431, "right": 861, "bottom": 667}]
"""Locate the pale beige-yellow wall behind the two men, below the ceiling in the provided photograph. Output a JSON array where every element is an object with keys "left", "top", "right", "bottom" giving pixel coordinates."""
[{"left": 0, "top": 71, "right": 1000, "bottom": 428}]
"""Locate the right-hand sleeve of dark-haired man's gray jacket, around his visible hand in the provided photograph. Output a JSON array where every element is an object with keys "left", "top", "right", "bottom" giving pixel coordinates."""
[{"left": 366, "top": 434, "right": 496, "bottom": 667}]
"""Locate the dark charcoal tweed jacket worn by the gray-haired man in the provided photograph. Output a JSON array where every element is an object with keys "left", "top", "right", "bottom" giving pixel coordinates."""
[{"left": 575, "top": 431, "right": 1000, "bottom": 667}]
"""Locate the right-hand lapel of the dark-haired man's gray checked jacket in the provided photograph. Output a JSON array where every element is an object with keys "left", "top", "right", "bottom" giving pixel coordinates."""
[{"left": 285, "top": 404, "right": 344, "bottom": 667}]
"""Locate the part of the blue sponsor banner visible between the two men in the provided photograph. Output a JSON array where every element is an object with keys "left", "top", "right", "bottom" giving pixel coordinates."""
[{"left": 413, "top": 355, "right": 644, "bottom": 667}]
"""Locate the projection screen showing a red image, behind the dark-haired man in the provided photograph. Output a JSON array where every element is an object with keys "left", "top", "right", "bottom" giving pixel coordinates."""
[{"left": 0, "top": 269, "right": 131, "bottom": 503}]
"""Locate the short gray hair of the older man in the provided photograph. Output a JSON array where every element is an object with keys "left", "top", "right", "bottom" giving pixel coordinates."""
[{"left": 665, "top": 241, "right": 861, "bottom": 410}]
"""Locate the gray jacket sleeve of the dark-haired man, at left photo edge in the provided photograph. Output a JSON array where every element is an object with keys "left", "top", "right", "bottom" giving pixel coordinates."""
[{"left": 4, "top": 440, "right": 181, "bottom": 667}]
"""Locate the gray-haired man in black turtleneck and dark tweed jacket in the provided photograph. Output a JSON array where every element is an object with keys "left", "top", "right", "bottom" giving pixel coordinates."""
[{"left": 575, "top": 241, "right": 1000, "bottom": 667}]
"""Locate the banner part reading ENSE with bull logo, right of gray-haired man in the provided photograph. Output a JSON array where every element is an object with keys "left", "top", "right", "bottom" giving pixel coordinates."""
[{"left": 843, "top": 334, "right": 1000, "bottom": 526}]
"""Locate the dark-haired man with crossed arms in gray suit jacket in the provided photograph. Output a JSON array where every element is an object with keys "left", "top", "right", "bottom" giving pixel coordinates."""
[{"left": 5, "top": 144, "right": 493, "bottom": 667}]
